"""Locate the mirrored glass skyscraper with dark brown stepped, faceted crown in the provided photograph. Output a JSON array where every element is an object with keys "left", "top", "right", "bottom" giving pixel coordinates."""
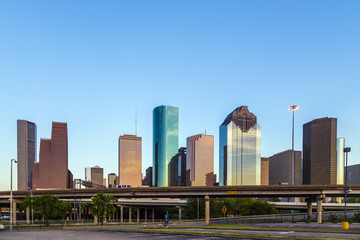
[{"left": 219, "top": 106, "right": 261, "bottom": 186}]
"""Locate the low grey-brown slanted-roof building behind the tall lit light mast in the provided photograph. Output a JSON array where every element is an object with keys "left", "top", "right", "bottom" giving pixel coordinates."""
[{"left": 269, "top": 150, "right": 302, "bottom": 185}]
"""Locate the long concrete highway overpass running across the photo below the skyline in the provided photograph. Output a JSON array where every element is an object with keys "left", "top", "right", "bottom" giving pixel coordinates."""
[{"left": 0, "top": 185, "right": 360, "bottom": 223}]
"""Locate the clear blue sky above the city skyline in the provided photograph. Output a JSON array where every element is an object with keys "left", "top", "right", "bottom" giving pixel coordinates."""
[{"left": 0, "top": 0, "right": 360, "bottom": 190}]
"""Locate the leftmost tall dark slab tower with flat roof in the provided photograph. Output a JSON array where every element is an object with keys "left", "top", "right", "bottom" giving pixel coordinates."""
[{"left": 17, "top": 120, "right": 36, "bottom": 191}]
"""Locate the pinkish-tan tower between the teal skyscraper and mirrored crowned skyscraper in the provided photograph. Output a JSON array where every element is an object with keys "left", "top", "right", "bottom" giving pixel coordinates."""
[{"left": 186, "top": 134, "right": 214, "bottom": 186}]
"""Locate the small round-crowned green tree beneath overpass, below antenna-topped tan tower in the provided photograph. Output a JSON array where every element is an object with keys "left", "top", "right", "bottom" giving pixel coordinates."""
[{"left": 90, "top": 192, "right": 117, "bottom": 224}]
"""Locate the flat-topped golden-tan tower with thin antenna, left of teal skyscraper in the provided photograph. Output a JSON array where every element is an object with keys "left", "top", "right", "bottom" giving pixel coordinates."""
[{"left": 119, "top": 134, "right": 142, "bottom": 187}]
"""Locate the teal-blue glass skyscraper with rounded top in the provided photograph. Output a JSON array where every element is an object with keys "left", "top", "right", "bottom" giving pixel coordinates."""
[{"left": 153, "top": 106, "right": 179, "bottom": 187}]
